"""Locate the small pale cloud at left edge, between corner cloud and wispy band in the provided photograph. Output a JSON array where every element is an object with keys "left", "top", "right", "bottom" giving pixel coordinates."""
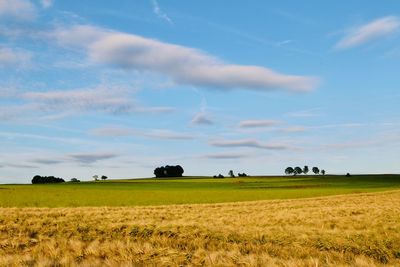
[{"left": 0, "top": 47, "right": 32, "bottom": 68}]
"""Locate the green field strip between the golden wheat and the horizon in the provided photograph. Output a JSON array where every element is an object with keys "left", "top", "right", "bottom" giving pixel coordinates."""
[{"left": 0, "top": 175, "right": 400, "bottom": 207}]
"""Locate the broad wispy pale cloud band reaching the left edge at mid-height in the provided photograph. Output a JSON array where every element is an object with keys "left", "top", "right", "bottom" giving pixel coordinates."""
[{"left": 0, "top": 86, "right": 174, "bottom": 120}]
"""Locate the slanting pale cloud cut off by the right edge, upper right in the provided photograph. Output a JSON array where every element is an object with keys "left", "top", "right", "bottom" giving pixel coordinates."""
[{"left": 336, "top": 16, "right": 400, "bottom": 49}]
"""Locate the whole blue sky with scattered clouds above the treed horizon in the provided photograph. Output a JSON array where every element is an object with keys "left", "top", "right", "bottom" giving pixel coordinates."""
[{"left": 0, "top": 0, "right": 400, "bottom": 183}]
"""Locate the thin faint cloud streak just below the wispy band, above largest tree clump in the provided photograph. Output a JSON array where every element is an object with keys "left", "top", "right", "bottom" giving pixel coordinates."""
[{"left": 91, "top": 127, "right": 196, "bottom": 140}]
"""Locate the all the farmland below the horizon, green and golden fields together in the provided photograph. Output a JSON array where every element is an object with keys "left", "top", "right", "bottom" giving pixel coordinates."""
[{"left": 0, "top": 175, "right": 400, "bottom": 266}]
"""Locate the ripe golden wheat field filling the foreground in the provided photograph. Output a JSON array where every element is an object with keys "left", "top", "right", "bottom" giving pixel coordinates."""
[{"left": 0, "top": 191, "right": 400, "bottom": 266}]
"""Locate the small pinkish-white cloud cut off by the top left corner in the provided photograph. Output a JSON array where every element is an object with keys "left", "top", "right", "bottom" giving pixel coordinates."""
[{"left": 0, "top": 0, "right": 37, "bottom": 21}]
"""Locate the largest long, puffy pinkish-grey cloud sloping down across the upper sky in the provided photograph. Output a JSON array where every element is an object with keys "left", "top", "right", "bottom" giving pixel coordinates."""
[{"left": 53, "top": 25, "right": 318, "bottom": 91}]
